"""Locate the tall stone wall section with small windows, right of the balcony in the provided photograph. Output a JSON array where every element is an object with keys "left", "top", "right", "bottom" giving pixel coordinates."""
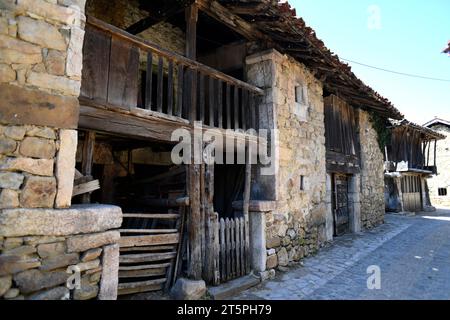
[{"left": 247, "top": 51, "right": 326, "bottom": 270}]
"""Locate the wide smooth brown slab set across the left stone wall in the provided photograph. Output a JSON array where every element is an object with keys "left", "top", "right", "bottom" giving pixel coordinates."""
[{"left": 0, "top": 84, "right": 80, "bottom": 129}]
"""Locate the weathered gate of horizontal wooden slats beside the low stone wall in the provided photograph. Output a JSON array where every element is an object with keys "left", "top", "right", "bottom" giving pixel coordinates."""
[{"left": 118, "top": 201, "right": 186, "bottom": 295}]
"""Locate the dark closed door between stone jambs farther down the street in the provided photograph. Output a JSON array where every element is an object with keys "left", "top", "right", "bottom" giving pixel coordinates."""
[{"left": 333, "top": 174, "right": 350, "bottom": 236}]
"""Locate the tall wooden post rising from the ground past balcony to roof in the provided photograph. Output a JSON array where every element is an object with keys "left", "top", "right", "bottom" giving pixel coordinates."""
[{"left": 185, "top": 4, "right": 205, "bottom": 280}]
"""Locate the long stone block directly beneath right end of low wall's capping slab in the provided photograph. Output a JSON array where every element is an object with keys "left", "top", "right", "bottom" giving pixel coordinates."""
[{"left": 67, "top": 231, "right": 120, "bottom": 252}]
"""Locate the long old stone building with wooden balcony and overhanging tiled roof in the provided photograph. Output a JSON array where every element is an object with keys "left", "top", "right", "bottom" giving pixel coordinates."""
[{"left": 0, "top": 0, "right": 402, "bottom": 299}]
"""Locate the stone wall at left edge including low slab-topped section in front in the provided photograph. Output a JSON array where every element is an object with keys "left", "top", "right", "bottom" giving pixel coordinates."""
[{"left": 0, "top": 0, "right": 122, "bottom": 300}]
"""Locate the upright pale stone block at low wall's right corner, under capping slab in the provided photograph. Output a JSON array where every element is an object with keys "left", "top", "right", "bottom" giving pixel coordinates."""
[{"left": 98, "top": 244, "right": 119, "bottom": 300}]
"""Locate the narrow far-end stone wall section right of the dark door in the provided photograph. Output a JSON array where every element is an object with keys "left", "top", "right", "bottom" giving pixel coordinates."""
[{"left": 359, "top": 110, "right": 385, "bottom": 229}]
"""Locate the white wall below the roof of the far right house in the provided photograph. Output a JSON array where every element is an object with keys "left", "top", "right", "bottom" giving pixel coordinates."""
[{"left": 428, "top": 125, "right": 450, "bottom": 208}]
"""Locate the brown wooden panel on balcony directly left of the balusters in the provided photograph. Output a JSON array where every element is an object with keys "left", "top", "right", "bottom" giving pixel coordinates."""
[{"left": 107, "top": 37, "right": 139, "bottom": 109}]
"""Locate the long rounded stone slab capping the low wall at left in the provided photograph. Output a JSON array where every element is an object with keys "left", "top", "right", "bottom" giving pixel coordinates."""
[{"left": 0, "top": 205, "right": 122, "bottom": 238}]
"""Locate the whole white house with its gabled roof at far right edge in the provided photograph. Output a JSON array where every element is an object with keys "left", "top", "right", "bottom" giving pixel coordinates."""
[{"left": 424, "top": 118, "right": 450, "bottom": 208}]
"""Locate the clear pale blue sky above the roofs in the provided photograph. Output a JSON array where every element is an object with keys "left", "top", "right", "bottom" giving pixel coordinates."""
[{"left": 289, "top": 0, "right": 450, "bottom": 124}]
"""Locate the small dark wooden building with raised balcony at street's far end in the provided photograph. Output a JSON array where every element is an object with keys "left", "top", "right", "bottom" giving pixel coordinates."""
[{"left": 385, "top": 120, "right": 444, "bottom": 212}]
